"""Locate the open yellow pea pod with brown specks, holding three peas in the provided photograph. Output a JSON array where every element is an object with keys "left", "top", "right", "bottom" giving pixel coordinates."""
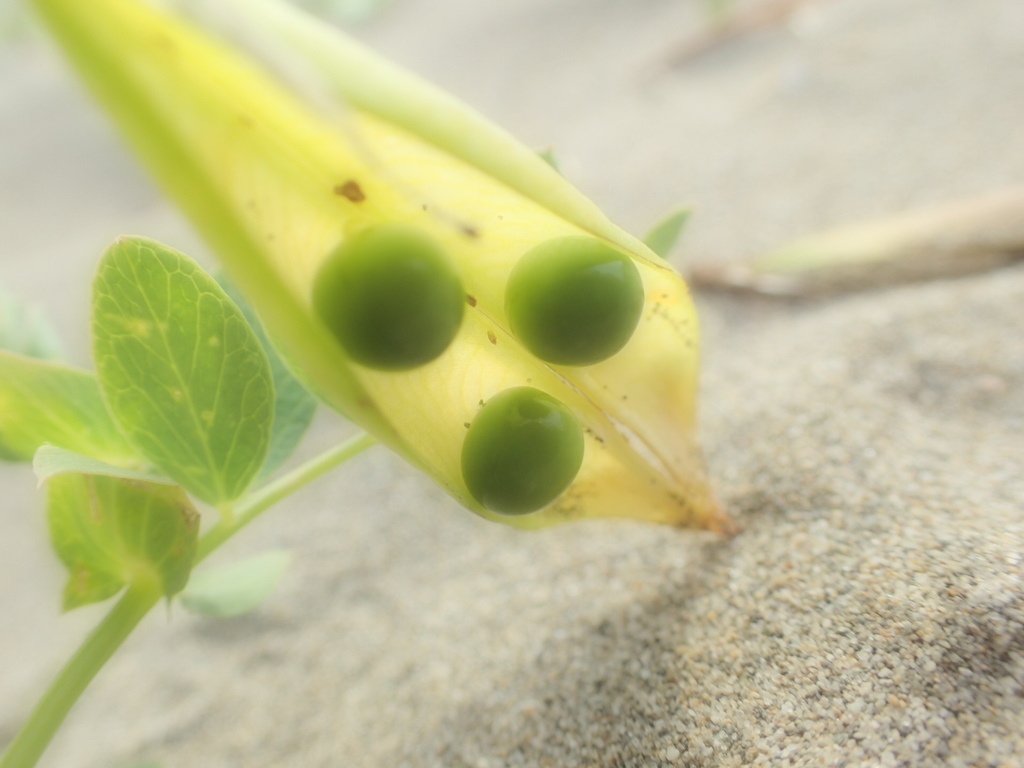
[{"left": 32, "top": 0, "right": 730, "bottom": 530}]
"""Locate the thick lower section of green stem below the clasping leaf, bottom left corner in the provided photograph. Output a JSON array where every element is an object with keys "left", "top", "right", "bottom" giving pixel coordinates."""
[{"left": 0, "top": 583, "right": 161, "bottom": 768}]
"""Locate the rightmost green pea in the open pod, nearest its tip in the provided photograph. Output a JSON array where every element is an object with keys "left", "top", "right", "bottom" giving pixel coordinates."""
[{"left": 505, "top": 237, "right": 644, "bottom": 366}]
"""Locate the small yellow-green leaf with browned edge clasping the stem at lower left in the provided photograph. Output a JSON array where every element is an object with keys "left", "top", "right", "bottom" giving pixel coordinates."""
[{"left": 46, "top": 473, "right": 199, "bottom": 610}]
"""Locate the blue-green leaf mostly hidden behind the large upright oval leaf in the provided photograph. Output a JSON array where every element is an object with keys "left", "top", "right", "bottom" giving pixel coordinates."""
[{"left": 216, "top": 273, "right": 316, "bottom": 481}]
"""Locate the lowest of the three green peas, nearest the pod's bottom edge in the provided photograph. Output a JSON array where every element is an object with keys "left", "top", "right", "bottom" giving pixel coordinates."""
[{"left": 462, "top": 387, "right": 584, "bottom": 515}]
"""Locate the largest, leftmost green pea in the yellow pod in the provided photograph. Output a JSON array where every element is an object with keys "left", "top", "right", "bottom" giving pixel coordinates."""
[{"left": 313, "top": 224, "right": 465, "bottom": 371}]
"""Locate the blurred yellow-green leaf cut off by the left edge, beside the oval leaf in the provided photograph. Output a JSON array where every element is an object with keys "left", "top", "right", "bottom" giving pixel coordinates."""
[{"left": 0, "top": 350, "right": 138, "bottom": 465}]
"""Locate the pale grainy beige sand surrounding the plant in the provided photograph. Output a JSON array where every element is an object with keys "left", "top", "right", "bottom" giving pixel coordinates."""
[{"left": 0, "top": 0, "right": 1024, "bottom": 768}]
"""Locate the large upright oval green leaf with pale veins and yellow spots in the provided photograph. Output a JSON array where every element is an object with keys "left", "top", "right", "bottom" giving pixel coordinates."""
[{"left": 92, "top": 238, "right": 273, "bottom": 504}]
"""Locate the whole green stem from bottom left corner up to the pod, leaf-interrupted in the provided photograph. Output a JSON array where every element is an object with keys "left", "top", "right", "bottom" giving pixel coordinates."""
[{"left": 0, "top": 432, "right": 375, "bottom": 768}]
